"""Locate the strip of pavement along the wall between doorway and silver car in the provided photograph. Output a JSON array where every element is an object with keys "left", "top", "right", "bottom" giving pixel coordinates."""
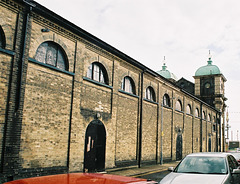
[{"left": 106, "top": 161, "right": 178, "bottom": 177}]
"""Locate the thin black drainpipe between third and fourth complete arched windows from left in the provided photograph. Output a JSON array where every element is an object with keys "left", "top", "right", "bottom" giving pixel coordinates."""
[{"left": 138, "top": 69, "right": 145, "bottom": 168}]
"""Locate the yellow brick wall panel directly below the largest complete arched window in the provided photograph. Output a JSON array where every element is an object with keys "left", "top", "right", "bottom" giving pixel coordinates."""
[{"left": 20, "top": 63, "right": 72, "bottom": 168}]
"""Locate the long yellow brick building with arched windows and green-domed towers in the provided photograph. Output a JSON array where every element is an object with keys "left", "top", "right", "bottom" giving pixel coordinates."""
[{"left": 0, "top": 0, "right": 226, "bottom": 182}]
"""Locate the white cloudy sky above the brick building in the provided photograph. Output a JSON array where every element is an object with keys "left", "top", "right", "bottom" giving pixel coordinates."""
[{"left": 36, "top": 0, "right": 240, "bottom": 140}]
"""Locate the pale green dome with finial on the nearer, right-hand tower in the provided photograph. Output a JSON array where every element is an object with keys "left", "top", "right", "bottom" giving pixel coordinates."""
[{"left": 195, "top": 58, "right": 221, "bottom": 76}]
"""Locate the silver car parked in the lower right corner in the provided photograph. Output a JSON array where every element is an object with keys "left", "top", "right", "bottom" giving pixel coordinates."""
[{"left": 160, "top": 153, "right": 240, "bottom": 184}]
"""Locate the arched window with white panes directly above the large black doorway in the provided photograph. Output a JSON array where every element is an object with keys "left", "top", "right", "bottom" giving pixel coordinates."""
[{"left": 87, "top": 62, "right": 109, "bottom": 85}]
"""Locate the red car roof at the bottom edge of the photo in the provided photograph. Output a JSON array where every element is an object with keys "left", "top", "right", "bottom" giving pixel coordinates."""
[{"left": 4, "top": 173, "right": 157, "bottom": 184}]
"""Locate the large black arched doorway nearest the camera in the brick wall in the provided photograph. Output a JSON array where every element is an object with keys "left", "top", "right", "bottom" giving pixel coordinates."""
[{"left": 84, "top": 120, "right": 106, "bottom": 172}]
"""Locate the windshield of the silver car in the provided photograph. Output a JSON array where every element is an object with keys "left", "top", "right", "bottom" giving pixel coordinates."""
[{"left": 174, "top": 156, "right": 227, "bottom": 174}]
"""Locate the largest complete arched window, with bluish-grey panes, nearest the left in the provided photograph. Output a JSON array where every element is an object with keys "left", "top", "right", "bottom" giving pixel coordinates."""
[{"left": 35, "top": 41, "right": 68, "bottom": 70}]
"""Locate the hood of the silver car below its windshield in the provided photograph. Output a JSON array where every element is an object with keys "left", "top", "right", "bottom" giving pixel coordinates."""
[{"left": 160, "top": 172, "right": 227, "bottom": 184}]
